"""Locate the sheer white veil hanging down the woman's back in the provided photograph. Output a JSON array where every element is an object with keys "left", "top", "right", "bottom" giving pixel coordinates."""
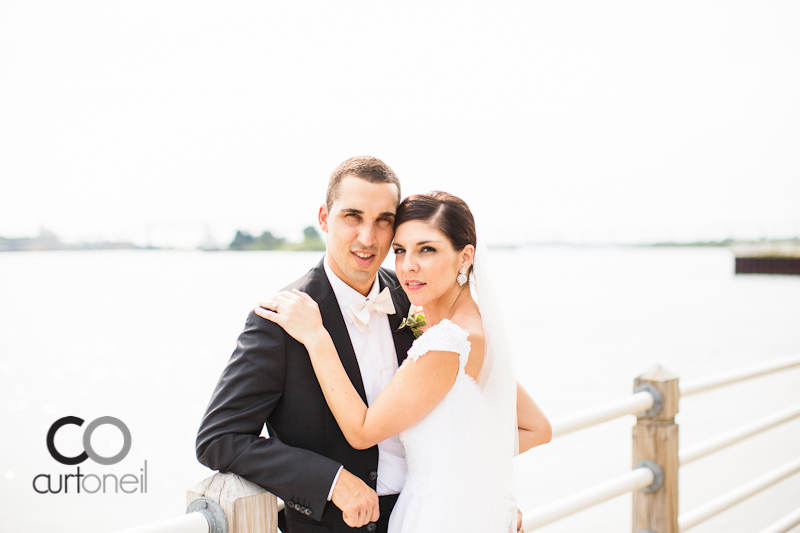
[{"left": 470, "top": 239, "right": 519, "bottom": 532}]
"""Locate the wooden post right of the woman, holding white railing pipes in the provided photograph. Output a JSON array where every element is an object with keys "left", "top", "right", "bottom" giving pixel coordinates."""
[{"left": 633, "top": 365, "right": 680, "bottom": 533}]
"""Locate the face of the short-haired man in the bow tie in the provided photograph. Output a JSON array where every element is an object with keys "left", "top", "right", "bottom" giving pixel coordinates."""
[{"left": 319, "top": 176, "right": 397, "bottom": 295}]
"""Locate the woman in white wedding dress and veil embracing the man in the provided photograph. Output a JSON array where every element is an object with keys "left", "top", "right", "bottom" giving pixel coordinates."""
[{"left": 256, "top": 192, "right": 550, "bottom": 533}]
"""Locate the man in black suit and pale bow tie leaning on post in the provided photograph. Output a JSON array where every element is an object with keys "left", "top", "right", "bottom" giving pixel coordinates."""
[{"left": 197, "top": 156, "right": 414, "bottom": 533}]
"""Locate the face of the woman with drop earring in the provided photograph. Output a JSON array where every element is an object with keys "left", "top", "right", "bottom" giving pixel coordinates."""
[{"left": 392, "top": 220, "right": 462, "bottom": 306}]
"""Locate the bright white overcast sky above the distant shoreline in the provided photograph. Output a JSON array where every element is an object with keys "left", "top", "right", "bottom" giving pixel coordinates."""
[{"left": 0, "top": 0, "right": 800, "bottom": 246}]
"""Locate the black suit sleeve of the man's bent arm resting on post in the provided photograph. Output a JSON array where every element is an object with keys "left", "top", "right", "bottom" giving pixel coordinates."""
[{"left": 196, "top": 311, "right": 341, "bottom": 520}]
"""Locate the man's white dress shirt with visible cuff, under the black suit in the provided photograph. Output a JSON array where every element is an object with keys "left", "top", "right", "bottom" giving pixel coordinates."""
[{"left": 325, "top": 255, "right": 406, "bottom": 494}]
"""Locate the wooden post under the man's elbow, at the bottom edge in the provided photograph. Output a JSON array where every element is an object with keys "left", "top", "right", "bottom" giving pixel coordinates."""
[{"left": 186, "top": 472, "right": 278, "bottom": 533}]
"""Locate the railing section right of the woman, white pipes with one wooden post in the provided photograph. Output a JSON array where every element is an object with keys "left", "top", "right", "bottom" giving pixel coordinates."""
[{"left": 523, "top": 355, "right": 800, "bottom": 533}]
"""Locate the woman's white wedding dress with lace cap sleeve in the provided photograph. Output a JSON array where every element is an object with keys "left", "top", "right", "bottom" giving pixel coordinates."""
[{"left": 389, "top": 319, "right": 516, "bottom": 533}]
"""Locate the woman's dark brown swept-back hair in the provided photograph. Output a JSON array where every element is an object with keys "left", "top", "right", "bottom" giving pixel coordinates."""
[{"left": 394, "top": 191, "right": 478, "bottom": 271}]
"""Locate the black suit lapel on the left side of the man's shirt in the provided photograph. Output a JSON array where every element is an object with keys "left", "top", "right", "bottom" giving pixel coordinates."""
[{"left": 309, "top": 258, "right": 369, "bottom": 405}]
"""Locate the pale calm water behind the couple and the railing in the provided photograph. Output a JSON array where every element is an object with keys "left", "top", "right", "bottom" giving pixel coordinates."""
[{"left": 0, "top": 248, "right": 800, "bottom": 533}]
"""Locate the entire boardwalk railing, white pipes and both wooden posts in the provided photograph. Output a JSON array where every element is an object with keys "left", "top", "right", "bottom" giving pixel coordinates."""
[{"left": 112, "top": 355, "right": 800, "bottom": 533}]
